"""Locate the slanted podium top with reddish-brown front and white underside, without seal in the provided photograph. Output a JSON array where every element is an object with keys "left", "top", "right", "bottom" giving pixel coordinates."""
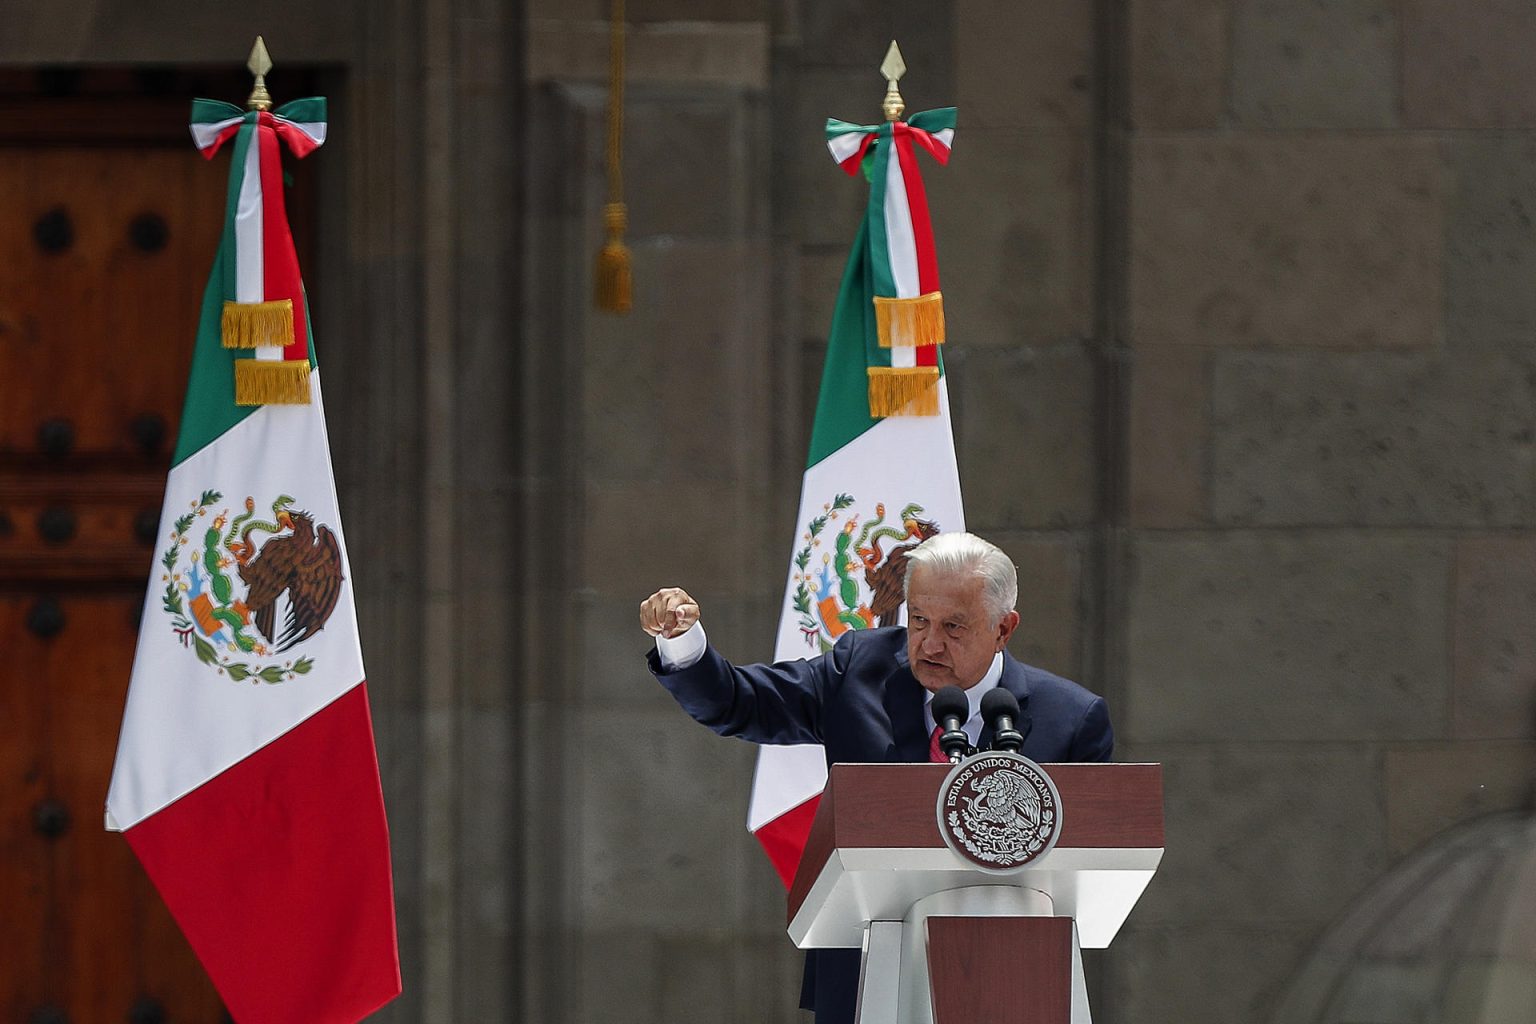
[{"left": 788, "top": 763, "right": 1163, "bottom": 947}]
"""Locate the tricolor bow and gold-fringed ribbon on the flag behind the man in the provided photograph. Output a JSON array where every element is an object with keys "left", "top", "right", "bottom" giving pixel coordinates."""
[{"left": 826, "top": 107, "right": 955, "bottom": 416}]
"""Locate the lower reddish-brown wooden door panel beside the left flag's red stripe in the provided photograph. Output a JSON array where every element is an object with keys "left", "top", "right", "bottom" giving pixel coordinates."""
[{"left": 0, "top": 591, "right": 221, "bottom": 1022}]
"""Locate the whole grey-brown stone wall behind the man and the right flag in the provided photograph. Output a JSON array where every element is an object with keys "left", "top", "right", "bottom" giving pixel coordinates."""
[{"left": 0, "top": 0, "right": 1536, "bottom": 1024}]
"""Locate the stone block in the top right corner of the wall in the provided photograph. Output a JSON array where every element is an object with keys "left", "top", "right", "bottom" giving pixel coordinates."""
[{"left": 1402, "top": 0, "right": 1536, "bottom": 129}]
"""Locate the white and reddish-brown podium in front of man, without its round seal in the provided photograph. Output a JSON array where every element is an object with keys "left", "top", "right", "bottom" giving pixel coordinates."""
[{"left": 790, "top": 765, "right": 1163, "bottom": 1024}]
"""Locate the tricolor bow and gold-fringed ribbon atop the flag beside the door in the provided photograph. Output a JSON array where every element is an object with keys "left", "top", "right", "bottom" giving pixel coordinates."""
[{"left": 190, "top": 97, "right": 326, "bottom": 405}]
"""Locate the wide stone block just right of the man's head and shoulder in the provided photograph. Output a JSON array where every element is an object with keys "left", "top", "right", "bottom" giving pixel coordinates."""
[{"left": 1118, "top": 533, "right": 1452, "bottom": 742}]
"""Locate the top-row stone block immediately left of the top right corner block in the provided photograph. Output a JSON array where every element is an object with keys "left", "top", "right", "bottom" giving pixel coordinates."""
[{"left": 1232, "top": 0, "right": 1398, "bottom": 129}]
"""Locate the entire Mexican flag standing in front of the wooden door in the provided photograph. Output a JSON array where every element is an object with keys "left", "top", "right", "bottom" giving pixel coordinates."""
[{"left": 106, "top": 100, "right": 401, "bottom": 1024}]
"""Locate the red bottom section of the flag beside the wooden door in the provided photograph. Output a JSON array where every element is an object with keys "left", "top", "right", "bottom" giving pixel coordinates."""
[{"left": 123, "top": 683, "right": 399, "bottom": 1024}]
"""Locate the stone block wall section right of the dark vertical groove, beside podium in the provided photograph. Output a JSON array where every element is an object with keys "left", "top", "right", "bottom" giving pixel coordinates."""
[{"left": 1111, "top": 0, "right": 1536, "bottom": 1021}]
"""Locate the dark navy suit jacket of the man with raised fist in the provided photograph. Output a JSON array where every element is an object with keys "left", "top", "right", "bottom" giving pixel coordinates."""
[{"left": 650, "top": 626, "right": 1115, "bottom": 1024}]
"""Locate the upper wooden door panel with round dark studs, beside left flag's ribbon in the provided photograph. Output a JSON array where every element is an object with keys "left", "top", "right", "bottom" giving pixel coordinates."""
[{"left": 0, "top": 145, "right": 226, "bottom": 461}]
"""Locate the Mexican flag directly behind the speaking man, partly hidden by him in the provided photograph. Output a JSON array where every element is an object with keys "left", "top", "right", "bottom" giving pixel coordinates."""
[{"left": 746, "top": 107, "right": 965, "bottom": 886}]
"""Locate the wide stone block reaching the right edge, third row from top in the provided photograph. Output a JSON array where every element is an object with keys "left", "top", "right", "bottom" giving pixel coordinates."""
[{"left": 1210, "top": 353, "right": 1536, "bottom": 527}]
